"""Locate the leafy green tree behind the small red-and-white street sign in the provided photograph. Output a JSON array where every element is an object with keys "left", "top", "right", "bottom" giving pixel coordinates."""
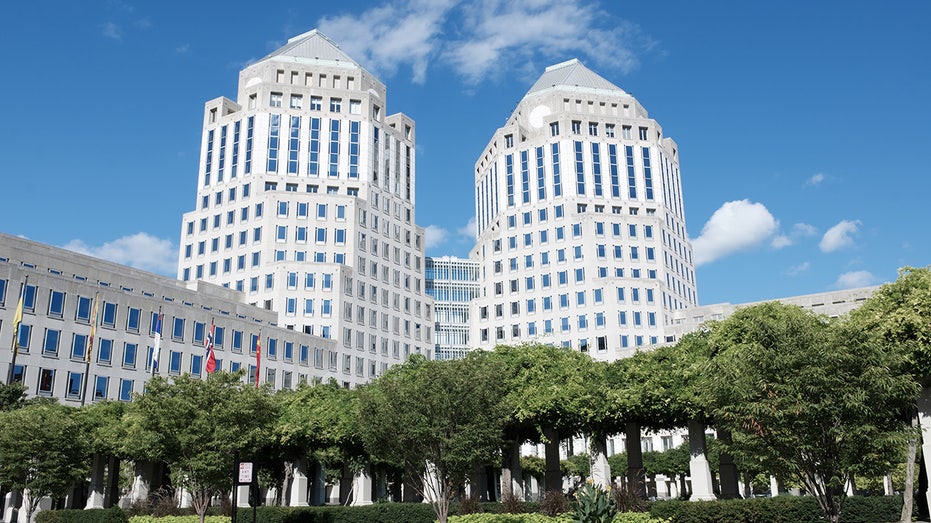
[{"left": 124, "top": 372, "right": 277, "bottom": 523}]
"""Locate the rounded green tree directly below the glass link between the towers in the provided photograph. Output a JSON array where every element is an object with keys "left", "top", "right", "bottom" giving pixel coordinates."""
[{"left": 359, "top": 353, "right": 504, "bottom": 523}]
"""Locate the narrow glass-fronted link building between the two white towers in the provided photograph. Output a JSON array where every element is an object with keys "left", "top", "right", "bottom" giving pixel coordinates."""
[{"left": 426, "top": 256, "right": 479, "bottom": 360}]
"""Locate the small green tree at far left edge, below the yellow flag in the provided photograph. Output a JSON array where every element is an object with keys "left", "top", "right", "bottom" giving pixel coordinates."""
[{"left": 0, "top": 401, "right": 87, "bottom": 521}]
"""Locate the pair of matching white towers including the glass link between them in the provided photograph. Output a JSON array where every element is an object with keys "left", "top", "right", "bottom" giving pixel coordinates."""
[{"left": 178, "top": 31, "right": 697, "bottom": 380}]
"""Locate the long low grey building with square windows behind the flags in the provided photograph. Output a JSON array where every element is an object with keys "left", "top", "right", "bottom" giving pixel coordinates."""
[{"left": 0, "top": 234, "right": 339, "bottom": 405}]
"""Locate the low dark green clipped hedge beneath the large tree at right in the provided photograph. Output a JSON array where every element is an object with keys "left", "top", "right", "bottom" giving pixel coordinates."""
[{"left": 650, "top": 496, "right": 902, "bottom": 523}]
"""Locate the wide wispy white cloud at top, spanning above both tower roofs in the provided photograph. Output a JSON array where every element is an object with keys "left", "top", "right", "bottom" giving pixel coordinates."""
[{"left": 317, "top": 0, "right": 657, "bottom": 85}]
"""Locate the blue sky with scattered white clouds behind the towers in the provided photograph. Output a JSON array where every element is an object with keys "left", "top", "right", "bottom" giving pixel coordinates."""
[{"left": 0, "top": 0, "right": 931, "bottom": 304}]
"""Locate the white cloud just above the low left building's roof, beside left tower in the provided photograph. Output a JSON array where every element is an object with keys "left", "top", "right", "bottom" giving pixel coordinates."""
[{"left": 63, "top": 232, "right": 178, "bottom": 276}]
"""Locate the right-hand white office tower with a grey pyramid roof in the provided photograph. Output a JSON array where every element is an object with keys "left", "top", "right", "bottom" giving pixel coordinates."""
[{"left": 471, "top": 60, "right": 697, "bottom": 360}]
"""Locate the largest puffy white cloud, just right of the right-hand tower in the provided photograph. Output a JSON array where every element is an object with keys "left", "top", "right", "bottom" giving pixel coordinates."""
[{"left": 692, "top": 200, "right": 779, "bottom": 266}]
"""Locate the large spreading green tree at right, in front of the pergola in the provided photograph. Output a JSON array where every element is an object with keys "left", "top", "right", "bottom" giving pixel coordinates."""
[{"left": 701, "top": 303, "right": 917, "bottom": 522}]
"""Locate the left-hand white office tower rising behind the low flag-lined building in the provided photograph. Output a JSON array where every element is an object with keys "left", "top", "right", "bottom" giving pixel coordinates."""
[{"left": 178, "top": 30, "right": 433, "bottom": 385}]
